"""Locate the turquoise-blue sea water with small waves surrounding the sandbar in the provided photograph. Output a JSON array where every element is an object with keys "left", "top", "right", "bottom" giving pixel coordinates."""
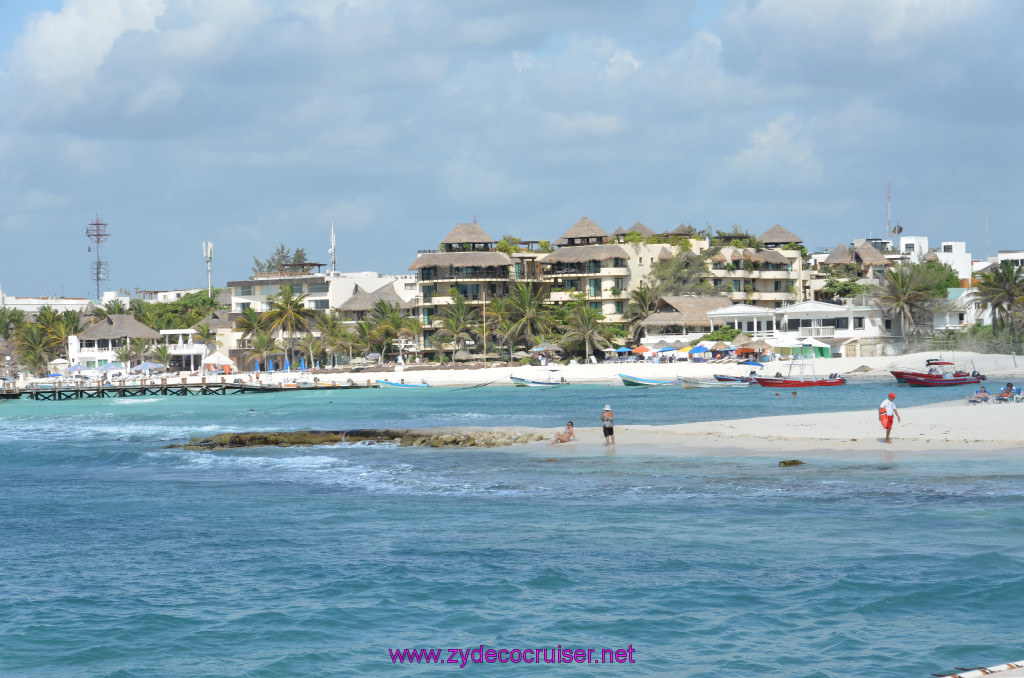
[{"left": 0, "top": 382, "right": 1024, "bottom": 678}]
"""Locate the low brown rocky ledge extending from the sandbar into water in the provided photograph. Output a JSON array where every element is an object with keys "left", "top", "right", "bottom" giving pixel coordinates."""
[{"left": 167, "top": 428, "right": 549, "bottom": 451}]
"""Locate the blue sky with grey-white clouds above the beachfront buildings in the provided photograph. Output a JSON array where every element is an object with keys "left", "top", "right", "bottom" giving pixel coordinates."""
[{"left": 0, "top": 0, "right": 1024, "bottom": 297}]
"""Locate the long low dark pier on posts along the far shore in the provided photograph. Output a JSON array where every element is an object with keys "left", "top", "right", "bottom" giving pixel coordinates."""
[{"left": 0, "top": 380, "right": 380, "bottom": 400}]
